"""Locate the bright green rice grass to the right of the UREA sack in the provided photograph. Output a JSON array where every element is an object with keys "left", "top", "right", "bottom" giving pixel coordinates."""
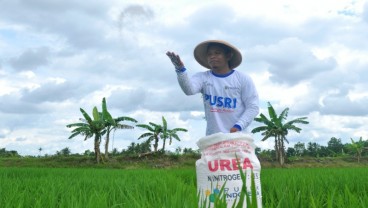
[{"left": 262, "top": 167, "right": 368, "bottom": 208}]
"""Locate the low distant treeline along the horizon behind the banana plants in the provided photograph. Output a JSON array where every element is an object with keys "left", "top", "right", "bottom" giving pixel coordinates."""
[{"left": 0, "top": 137, "right": 368, "bottom": 162}]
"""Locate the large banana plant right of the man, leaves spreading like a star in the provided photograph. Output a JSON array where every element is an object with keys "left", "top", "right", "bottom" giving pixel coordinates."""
[{"left": 252, "top": 102, "right": 309, "bottom": 166}]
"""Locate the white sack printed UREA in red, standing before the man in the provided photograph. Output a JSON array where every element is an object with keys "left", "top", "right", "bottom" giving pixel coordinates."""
[{"left": 196, "top": 133, "right": 262, "bottom": 207}]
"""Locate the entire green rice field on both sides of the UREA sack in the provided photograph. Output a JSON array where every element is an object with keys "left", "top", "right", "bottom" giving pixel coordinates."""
[{"left": 0, "top": 168, "right": 368, "bottom": 208}]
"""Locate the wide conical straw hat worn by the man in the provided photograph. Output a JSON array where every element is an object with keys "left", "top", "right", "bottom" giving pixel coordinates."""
[{"left": 194, "top": 40, "right": 242, "bottom": 69}]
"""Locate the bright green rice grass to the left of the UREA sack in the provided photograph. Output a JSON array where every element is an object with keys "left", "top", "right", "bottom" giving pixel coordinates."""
[{"left": 0, "top": 168, "right": 196, "bottom": 208}]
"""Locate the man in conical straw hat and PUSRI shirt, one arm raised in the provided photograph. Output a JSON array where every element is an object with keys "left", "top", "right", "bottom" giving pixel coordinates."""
[{"left": 166, "top": 40, "right": 259, "bottom": 135}]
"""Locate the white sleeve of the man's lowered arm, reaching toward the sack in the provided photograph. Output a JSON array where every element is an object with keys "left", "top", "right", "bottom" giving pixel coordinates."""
[{"left": 234, "top": 76, "right": 259, "bottom": 130}]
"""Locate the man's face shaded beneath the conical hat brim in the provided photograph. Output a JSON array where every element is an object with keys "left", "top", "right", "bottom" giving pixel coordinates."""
[{"left": 207, "top": 46, "right": 230, "bottom": 70}]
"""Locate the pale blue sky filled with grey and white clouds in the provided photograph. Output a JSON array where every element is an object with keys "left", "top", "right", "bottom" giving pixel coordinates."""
[{"left": 0, "top": 0, "right": 368, "bottom": 155}]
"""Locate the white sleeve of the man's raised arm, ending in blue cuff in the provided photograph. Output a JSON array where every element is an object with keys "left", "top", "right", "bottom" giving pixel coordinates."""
[{"left": 177, "top": 68, "right": 203, "bottom": 95}]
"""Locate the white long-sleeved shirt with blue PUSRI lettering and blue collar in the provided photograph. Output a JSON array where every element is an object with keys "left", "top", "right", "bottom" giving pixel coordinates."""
[{"left": 177, "top": 70, "right": 259, "bottom": 135}]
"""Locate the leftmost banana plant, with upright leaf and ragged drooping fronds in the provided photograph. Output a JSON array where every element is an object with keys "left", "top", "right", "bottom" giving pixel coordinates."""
[{"left": 66, "top": 98, "right": 116, "bottom": 163}]
